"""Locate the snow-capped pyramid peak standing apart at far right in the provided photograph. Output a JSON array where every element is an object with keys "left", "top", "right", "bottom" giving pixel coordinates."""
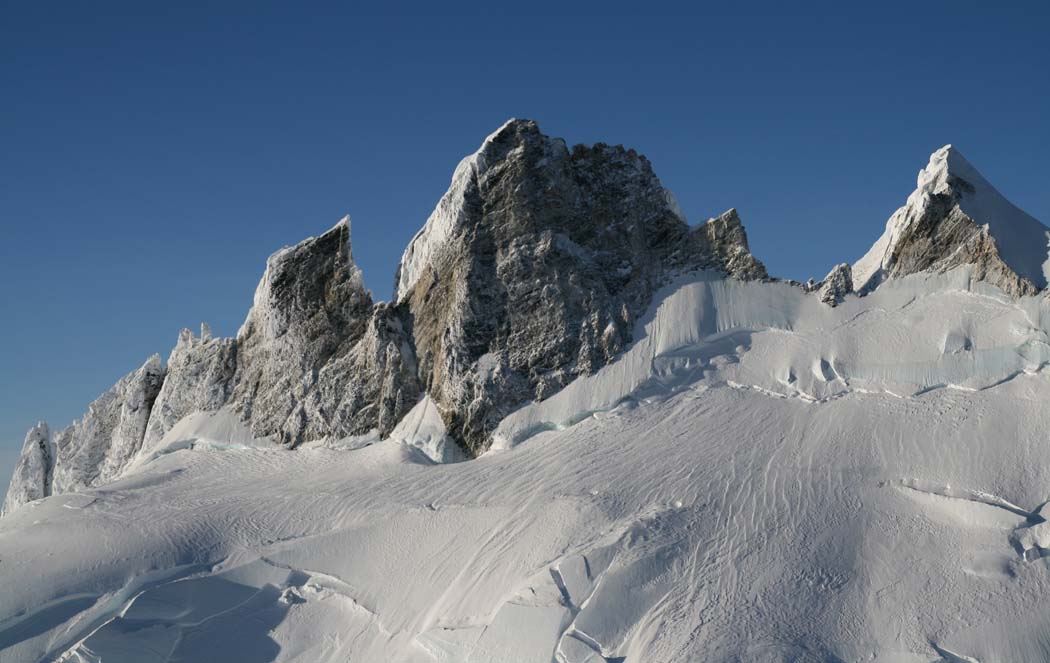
[{"left": 853, "top": 145, "right": 1050, "bottom": 295}]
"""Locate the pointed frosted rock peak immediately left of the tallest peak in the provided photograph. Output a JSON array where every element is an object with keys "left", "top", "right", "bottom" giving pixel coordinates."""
[{"left": 231, "top": 219, "right": 418, "bottom": 447}]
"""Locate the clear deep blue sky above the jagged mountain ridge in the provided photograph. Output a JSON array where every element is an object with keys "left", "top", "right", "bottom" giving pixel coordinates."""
[{"left": 0, "top": 0, "right": 1050, "bottom": 491}]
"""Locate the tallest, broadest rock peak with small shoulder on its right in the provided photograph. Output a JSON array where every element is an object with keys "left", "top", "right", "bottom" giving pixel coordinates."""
[{"left": 396, "top": 120, "right": 765, "bottom": 453}]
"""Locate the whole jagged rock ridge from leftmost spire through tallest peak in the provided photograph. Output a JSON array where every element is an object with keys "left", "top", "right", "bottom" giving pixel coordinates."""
[{"left": 2, "top": 120, "right": 767, "bottom": 507}]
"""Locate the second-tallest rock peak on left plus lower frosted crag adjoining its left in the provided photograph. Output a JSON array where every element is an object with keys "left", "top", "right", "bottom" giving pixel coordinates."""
[{"left": 143, "top": 217, "right": 419, "bottom": 450}]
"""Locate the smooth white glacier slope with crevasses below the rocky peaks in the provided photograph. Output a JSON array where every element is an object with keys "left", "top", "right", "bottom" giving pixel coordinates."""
[{"left": 6, "top": 272, "right": 1050, "bottom": 663}]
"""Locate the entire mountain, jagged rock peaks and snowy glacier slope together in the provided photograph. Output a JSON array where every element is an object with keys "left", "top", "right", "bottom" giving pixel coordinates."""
[{"left": 0, "top": 120, "right": 1050, "bottom": 663}]
